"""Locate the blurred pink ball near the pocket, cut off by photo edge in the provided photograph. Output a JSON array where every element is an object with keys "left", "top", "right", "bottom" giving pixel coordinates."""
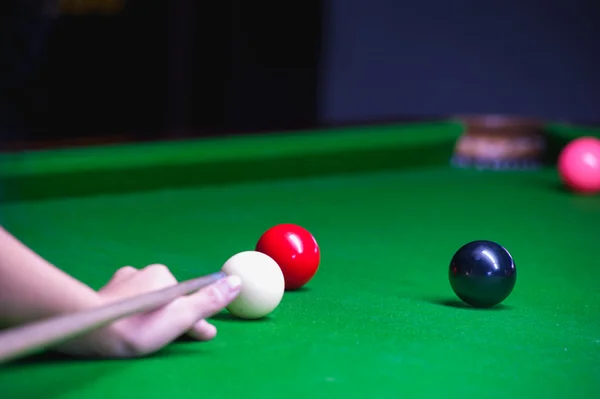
[{"left": 557, "top": 137, "right": 600, "bottom": 194}]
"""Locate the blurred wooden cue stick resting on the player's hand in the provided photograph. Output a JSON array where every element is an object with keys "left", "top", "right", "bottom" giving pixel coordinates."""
[{"left": 0, "top": 272, "right": 225, "bottom": 364}]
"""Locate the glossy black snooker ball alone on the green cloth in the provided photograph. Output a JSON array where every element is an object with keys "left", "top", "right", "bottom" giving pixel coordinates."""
[{"left": 449, "top": 240, "right": 517, "bottom": 308}]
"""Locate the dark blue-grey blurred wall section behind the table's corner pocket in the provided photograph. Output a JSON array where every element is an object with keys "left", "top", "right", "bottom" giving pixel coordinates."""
[{"left": 320, "top": 0, "right": 600, "bottom": 125}]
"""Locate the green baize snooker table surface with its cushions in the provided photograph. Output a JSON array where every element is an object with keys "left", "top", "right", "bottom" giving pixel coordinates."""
[{"left": 0, "top": 121, "right": 600, "bottom": 399}]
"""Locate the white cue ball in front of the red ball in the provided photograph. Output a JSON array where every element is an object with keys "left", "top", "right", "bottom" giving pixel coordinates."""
[{"left": 221, "top": 251, "right": 285, "bottom": 319}]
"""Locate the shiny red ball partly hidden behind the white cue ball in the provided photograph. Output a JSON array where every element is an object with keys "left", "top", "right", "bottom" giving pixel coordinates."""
[{"left": 256, "top": 224, "right": 321, "bottom": 290}]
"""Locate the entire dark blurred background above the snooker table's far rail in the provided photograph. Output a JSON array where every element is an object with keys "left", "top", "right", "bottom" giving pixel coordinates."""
[{"left": 0, "top": 0, "right": 600, "bottom": 148}]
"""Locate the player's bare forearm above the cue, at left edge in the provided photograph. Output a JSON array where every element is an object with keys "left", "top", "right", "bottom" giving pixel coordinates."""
[{"left": 0, "top": 227, "right": 101, "bottom": 325}]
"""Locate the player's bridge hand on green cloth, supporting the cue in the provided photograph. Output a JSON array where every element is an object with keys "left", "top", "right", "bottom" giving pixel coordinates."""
[{"left": 57, "top": 264, "right": 241, "bottom": 357}]
